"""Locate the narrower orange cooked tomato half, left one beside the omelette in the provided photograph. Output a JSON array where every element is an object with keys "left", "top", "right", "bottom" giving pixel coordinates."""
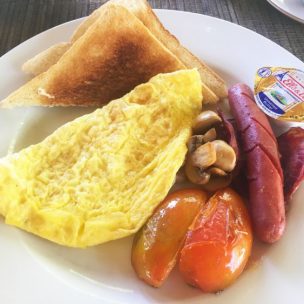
[{"left": 131, "top": 189, "right": 207, "bottom": 287}]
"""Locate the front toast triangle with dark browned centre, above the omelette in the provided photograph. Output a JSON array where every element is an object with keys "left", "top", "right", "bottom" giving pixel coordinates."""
[{"left": 1, "top": 4, "right": 190, "bottom": 107}]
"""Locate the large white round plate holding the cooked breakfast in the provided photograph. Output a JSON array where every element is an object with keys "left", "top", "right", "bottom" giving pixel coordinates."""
[{"left": 0, "top": 10, "right": 304, "bottom": 304}]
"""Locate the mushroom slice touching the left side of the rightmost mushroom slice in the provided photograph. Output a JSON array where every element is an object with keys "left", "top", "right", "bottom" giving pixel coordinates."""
[{"left": 191, "top": 142, "right": 217, "bottom": 170}]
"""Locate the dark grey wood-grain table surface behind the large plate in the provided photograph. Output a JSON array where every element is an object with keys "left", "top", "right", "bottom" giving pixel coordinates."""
[{"left": 0, "top": 0, "right": 304, "bottom": 61}]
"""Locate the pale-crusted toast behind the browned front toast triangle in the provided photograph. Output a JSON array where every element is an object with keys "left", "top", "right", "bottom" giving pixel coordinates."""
[{"left": 23, "top": 0, "right": 227, "bottom": 103}]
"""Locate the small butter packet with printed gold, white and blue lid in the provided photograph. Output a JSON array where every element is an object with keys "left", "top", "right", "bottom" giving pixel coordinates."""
[{"left": 254, "top": 67, "right": 304, "bottom": 122}]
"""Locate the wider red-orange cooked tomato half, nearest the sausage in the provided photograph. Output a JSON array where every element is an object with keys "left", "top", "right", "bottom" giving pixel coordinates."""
[{"left": 179, "top": 188, "right": 252, "bottom": 292}]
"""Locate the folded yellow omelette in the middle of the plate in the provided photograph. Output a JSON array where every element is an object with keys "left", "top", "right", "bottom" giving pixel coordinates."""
[{"left": 0, "top": 70, "right": 202, "bottom": 247}]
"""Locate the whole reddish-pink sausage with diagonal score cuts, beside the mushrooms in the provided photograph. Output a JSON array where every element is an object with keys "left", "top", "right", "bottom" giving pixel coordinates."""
[{"left": 228, "top": 84, "right": 285, "bottom": 243}]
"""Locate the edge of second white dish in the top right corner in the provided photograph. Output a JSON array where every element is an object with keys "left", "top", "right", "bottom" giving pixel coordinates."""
[{"left": 267, "top": 0, "right": 304, "bottom": 23}]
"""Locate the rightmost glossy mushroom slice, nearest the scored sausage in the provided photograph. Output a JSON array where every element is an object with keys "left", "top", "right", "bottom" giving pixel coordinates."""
[{"left": 212, "top": 140, "right": 236, "bottom": 172}]
